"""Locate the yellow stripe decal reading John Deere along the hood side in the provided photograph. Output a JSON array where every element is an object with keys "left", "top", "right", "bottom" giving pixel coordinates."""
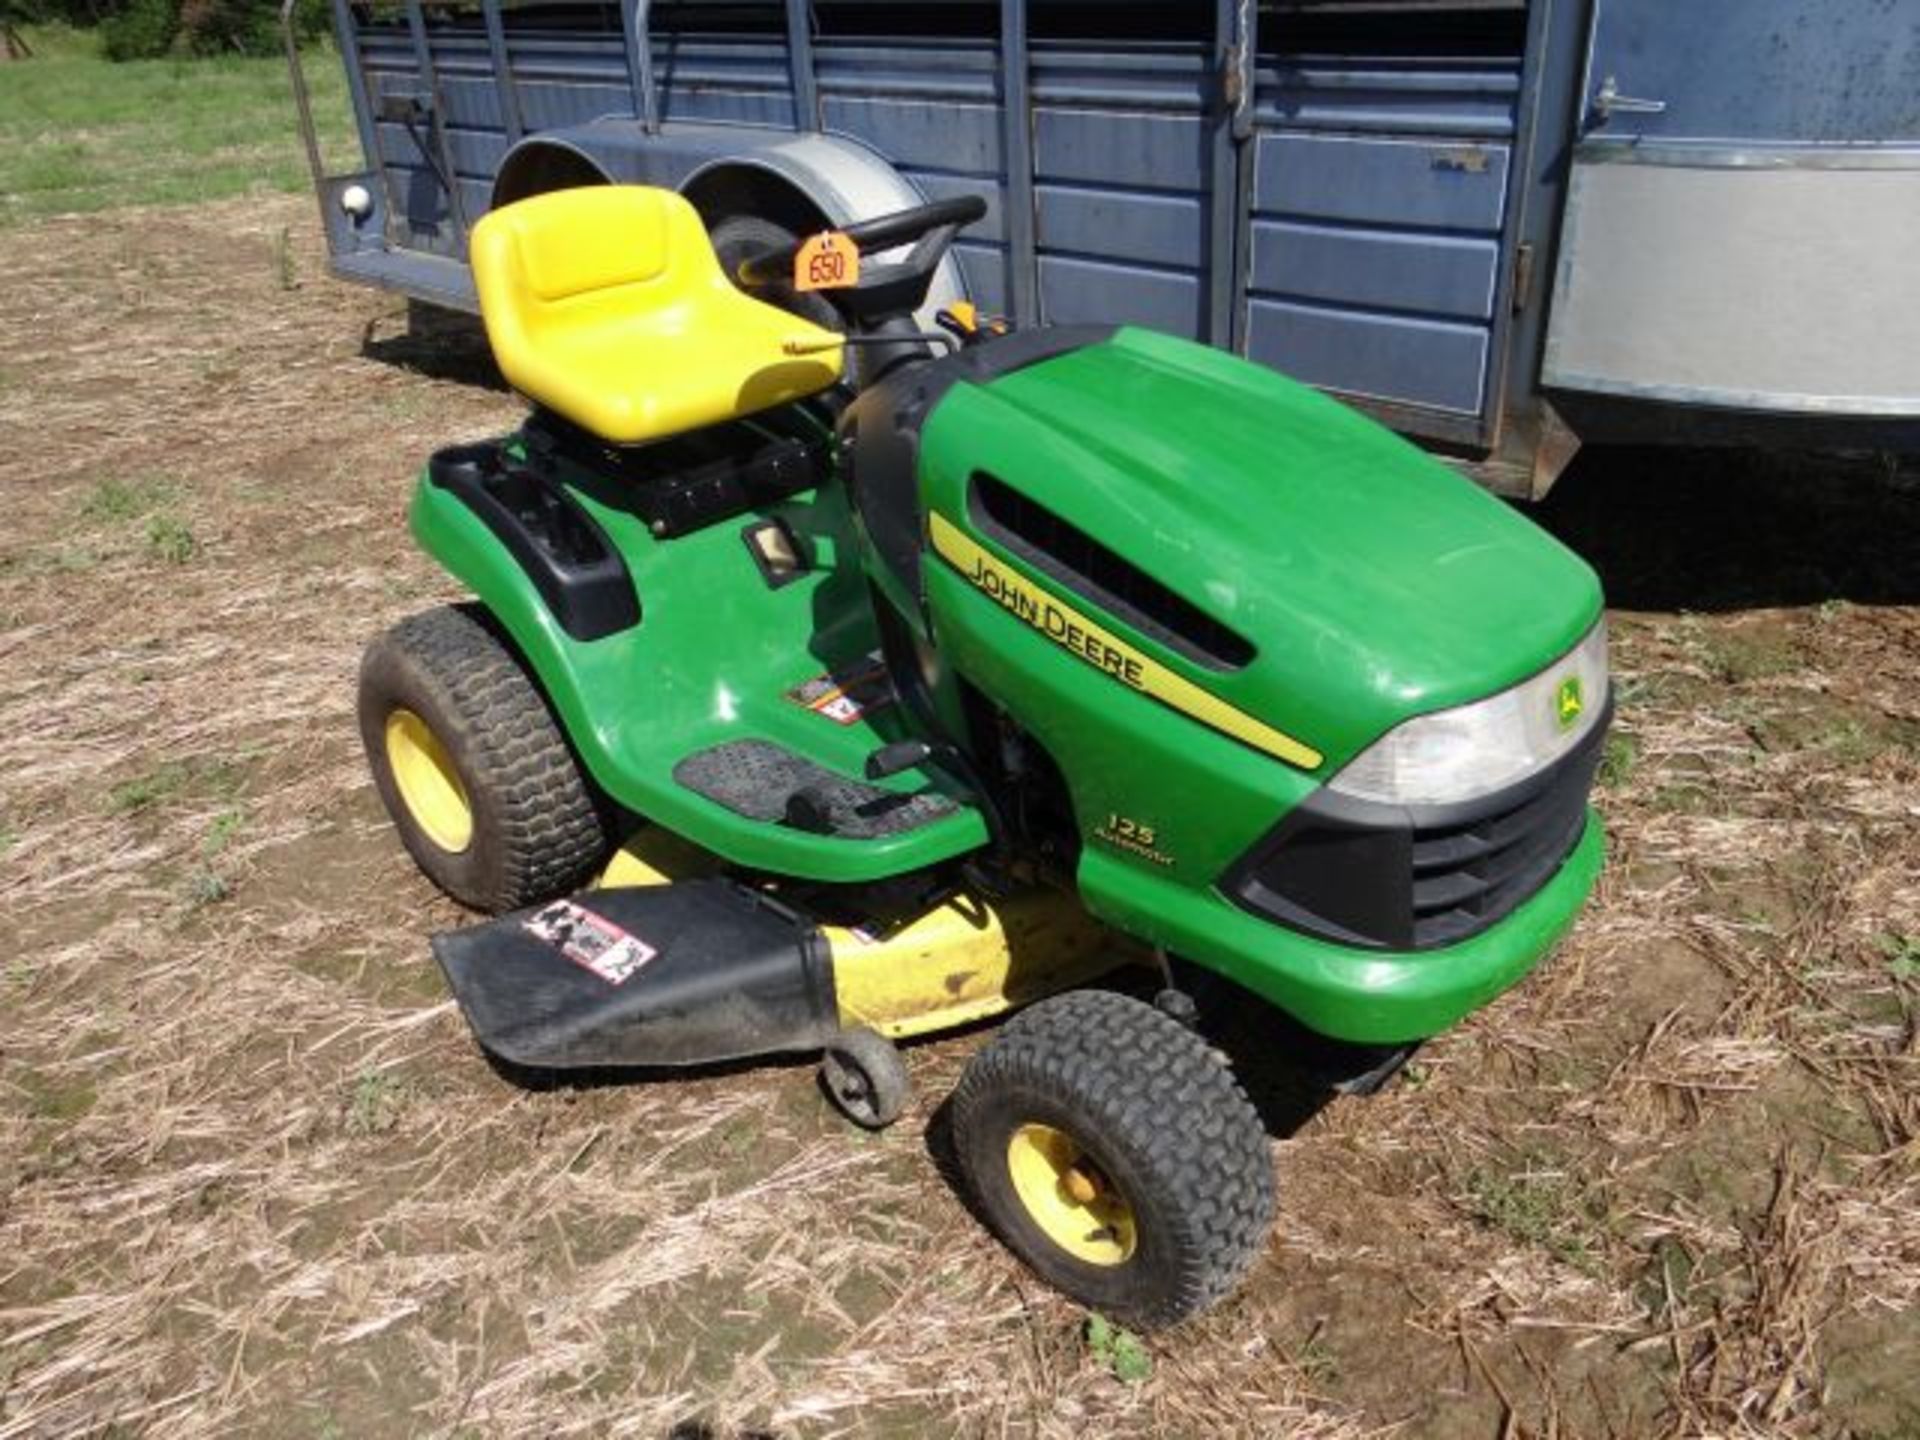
[{"left": 931, "top": 515, "right": 1323, "bottom": 770}]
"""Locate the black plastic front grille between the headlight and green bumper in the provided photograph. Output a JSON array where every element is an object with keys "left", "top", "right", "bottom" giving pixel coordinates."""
[{"left": 1221, "top": 705, "right": 1613, "bottom": 950}]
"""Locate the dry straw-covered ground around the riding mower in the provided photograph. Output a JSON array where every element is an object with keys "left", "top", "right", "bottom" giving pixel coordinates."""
[{"left": 0, "top": 200, "right": 1920, "bottom": 1440}]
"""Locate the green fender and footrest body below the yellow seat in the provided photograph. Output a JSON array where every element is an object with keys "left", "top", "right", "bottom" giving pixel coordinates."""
[{"left": 409, "top": 439, "right": 987, "bottom": 881}]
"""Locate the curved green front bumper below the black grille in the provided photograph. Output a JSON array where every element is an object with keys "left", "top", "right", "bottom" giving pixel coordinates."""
[{"left": 1081, "top": 812, "right": 1605, "bottom": 1044}]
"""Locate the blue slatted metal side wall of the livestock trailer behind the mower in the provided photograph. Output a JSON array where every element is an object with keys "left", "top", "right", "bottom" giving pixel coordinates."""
[{"left": 334, "top": 0, "right": 1524, "bottom": 438}]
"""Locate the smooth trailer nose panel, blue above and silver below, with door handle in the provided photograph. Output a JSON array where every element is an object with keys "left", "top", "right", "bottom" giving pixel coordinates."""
[{"left": 1542, "top": 0, "right": 1920, "bottom": 419}]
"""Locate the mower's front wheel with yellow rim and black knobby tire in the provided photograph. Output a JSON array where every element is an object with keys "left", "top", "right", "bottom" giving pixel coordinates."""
[{"left": 952, "top": 991, "right": 1273, "bottom": 1329}]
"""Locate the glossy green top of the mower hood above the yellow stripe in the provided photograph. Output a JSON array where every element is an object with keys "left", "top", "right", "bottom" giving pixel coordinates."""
[{"left": 922, "top": 328, "right": 1601, "bottom": 779}]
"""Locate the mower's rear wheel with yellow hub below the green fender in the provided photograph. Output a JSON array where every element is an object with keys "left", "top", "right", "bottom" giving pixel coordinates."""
[{"left": 359, "top": 609, "right": 611, "bottom": 912}]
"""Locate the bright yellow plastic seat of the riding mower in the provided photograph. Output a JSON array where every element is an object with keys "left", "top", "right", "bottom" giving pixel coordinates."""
[{"left": 468, "top": 184, "right": 841, "bottom": 445}]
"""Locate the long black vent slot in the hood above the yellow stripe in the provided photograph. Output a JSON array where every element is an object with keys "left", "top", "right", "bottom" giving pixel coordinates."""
[{"left": 972, "top": 472, "right": 1254, "bottom": 670}]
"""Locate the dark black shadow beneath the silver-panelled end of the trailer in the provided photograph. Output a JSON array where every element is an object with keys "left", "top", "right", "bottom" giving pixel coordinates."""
[{"left": 1526, "top": 445, "right": 1920, "bottom": 612}]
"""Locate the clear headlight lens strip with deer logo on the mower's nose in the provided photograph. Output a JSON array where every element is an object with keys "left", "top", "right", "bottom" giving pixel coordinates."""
[{"left": 1327, "top": 620, "right": 1607, "bottom": 804}]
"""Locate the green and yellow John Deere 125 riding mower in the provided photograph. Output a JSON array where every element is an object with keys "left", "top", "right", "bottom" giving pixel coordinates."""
[{"left": 359, "top": 186, "right": 1609, "bottom": 1325}]
